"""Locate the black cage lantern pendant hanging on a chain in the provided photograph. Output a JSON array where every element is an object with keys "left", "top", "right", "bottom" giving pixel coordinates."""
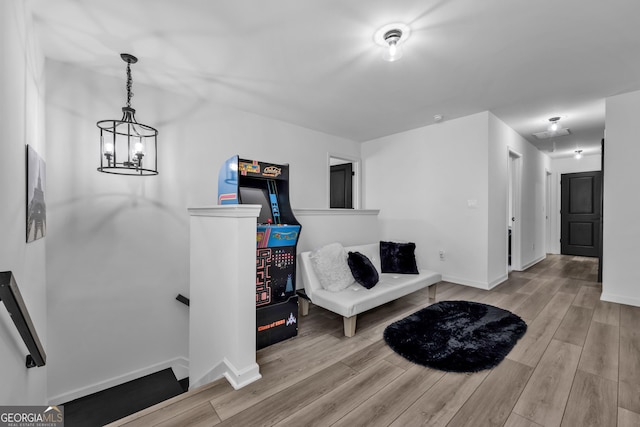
[{"left": 97, "top": 53, "right": 158, "bottom": 176}]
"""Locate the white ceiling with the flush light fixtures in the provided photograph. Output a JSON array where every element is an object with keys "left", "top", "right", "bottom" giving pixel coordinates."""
[{"left": 27, "top": 0, "right": 640, "bottom": 157}]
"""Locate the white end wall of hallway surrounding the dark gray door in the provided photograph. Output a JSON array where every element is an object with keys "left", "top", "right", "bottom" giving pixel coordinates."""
[{"left": 549, "top": 154, "right": 602, "bottom": 254}]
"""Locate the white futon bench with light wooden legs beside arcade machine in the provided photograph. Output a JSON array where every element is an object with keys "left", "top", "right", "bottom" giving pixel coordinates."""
[{"left": 298, "top": 243, "right": 442, "bottom": 337}]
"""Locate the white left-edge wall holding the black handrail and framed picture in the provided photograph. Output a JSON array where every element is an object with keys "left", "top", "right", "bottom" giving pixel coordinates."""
[{"left": 0, "top": 1, "right": 50, "bottom": 405}]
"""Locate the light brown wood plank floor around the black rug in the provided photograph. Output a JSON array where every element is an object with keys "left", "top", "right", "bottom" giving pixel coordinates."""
[{"left": 111, "top": 255, "right": 640, "bottom": 427}]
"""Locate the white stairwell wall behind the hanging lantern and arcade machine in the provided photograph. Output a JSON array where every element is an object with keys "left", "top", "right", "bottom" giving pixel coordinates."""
[{"left": 47, "top": 61, "right": 360, "bottom": 402}]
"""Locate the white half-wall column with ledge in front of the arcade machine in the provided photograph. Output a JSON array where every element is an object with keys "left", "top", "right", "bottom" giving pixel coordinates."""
[{"left": 189, "top": 205, "right": 261, "bottom": 389}]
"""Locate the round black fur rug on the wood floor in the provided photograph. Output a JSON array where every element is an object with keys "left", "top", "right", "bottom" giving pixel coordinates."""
[{"left": 384, "top": 301, "right": 527, "bottom": 372}]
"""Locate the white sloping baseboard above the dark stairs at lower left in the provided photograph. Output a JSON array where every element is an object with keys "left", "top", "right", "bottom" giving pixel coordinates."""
[{"left": 48, "top": 357, "right": 189, "bottom": 405}]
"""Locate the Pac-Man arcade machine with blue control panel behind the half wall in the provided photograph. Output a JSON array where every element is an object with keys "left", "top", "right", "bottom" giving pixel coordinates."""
[{"left": 218, "top": 156, "right": 301, "bottom": 349}]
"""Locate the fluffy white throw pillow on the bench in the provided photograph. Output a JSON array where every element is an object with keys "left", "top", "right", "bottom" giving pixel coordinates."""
[{"left": 309, "top": 243, "right": 354, "bottom": 292}]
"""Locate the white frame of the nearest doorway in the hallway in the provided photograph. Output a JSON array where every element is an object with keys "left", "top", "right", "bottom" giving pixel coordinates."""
[{"left": 505, "top": 147, "right": 522, "bottom": 271}]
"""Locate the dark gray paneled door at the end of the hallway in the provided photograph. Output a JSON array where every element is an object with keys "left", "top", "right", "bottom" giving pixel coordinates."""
[{"left": 560, "top": 171, "right": 602, "bottom": 257}]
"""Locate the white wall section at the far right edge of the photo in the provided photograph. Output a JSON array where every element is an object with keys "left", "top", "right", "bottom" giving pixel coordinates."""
[{"left": 601, "top": 88, "right": 640, "bottom": 306}]
